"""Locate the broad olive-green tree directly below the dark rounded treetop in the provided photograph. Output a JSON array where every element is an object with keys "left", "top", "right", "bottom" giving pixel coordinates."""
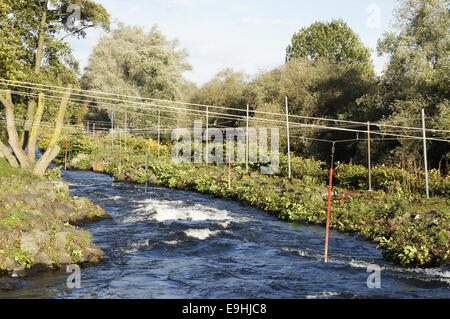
[{"left": 246, "top": 58, "right": 376, "bottom": 160}]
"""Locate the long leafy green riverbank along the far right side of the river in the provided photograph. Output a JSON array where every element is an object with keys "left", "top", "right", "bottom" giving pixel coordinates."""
[{"left": 40, "top": 137, "right": 450, "bottom": 267}]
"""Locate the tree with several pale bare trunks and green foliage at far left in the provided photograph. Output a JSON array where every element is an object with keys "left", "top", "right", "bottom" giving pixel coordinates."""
[{"left": 0, "top": 0, "right": 109, "bottom": 175}]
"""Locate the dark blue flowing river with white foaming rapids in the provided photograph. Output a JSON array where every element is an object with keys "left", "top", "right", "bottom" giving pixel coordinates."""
[{"left": 0, "top": 171, "right": 450, "bottom": 298}]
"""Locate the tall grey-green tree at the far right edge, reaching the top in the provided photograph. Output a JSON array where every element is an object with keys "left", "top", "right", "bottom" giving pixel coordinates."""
[{"left": 378, "top": 0, "right": 450, "bottom": 167}]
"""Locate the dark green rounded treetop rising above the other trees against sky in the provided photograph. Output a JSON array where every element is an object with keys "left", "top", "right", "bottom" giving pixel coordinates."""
[{"left": 286, "top": 20, "right": 371, "bottom": 65}]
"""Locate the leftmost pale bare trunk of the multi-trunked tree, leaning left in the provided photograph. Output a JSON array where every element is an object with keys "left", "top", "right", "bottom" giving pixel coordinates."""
[{"left": 0, "top": 90, "right": 33, "bottom": 170}]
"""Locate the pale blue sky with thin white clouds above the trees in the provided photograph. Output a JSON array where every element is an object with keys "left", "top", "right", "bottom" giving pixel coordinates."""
[{"left": 70, "top": 0, "right": 396, "bottom": 85}]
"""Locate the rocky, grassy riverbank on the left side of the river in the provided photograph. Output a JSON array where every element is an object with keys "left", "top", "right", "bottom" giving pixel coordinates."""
[{"left": 0, "top": 158, "right": 110, "bottom": 277}]
